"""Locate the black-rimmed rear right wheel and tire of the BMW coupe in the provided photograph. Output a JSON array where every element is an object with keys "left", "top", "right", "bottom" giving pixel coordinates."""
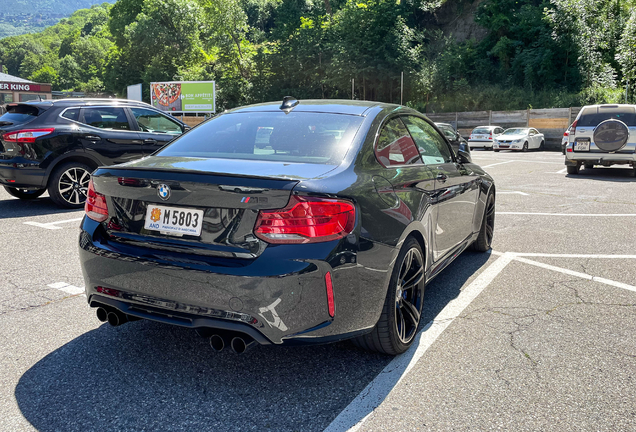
[{"left": 353, "top": 237, "right": 426, "bottom": 355}]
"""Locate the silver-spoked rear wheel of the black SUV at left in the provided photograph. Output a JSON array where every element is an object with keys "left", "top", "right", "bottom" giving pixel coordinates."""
[{"left": 48, "top": 162, "right": 93, "bottom": 208}]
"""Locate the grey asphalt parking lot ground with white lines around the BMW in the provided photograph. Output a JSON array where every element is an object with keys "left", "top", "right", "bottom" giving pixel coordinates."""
[{"left": 0, "top": 150, "right": 636, "bottom": 431}]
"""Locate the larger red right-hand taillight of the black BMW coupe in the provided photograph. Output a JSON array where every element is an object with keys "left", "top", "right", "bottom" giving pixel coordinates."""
[{"left": 254, "top": 195, "right": 356, "bottom": 244}]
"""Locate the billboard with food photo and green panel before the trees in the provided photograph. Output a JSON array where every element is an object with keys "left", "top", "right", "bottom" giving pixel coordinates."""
[{"left": 150, "top": 81, "right": 216, "bottom": 113}]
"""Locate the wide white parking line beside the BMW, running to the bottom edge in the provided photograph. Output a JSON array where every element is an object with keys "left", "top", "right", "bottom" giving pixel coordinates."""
[{"left": 325, "top": 254, "right": 512, "bottom": 432}]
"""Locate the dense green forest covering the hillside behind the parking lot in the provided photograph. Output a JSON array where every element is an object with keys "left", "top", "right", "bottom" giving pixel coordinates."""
[{"left": 0, "top": 0, "right": 636, "bottom": 112}]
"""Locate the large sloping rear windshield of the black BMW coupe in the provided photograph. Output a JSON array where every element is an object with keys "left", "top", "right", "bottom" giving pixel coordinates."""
[{"left": 156, "top": 111, "right": 362, "bottom": 164}]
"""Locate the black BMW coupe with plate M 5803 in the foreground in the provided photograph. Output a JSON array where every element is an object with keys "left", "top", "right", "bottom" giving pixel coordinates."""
[{"left": 79, "top": 97, "right": 495, "bottom": 354}]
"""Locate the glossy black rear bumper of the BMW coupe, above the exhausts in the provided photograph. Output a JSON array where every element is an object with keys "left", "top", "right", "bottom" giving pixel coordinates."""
[{"left": 79, "top": 218, "right": 391, "bottom": 344}]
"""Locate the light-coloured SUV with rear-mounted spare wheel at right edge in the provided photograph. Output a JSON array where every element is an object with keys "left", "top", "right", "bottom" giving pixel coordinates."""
[{"left": 565, "top": 104, "right": 636, "bottom": 176}]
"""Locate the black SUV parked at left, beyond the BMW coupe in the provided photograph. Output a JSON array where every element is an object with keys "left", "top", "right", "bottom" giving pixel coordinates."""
[{"left": 0, "top": 99, "right": 189, "bottom": 208}]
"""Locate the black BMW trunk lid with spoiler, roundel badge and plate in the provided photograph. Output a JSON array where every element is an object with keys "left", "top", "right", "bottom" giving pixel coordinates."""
[{"left": 93, "top": 157, "right": 335, "bottom": 259}]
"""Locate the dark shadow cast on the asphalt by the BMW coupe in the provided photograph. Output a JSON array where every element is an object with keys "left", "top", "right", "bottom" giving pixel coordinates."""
[{"left": 15, "top": 252, "right": 489, "bottom": 432}]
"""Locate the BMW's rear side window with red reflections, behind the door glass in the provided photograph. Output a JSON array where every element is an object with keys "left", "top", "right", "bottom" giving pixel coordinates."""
[{"left": 375, "top": 118, "right": 422, "bottom": 168}]
